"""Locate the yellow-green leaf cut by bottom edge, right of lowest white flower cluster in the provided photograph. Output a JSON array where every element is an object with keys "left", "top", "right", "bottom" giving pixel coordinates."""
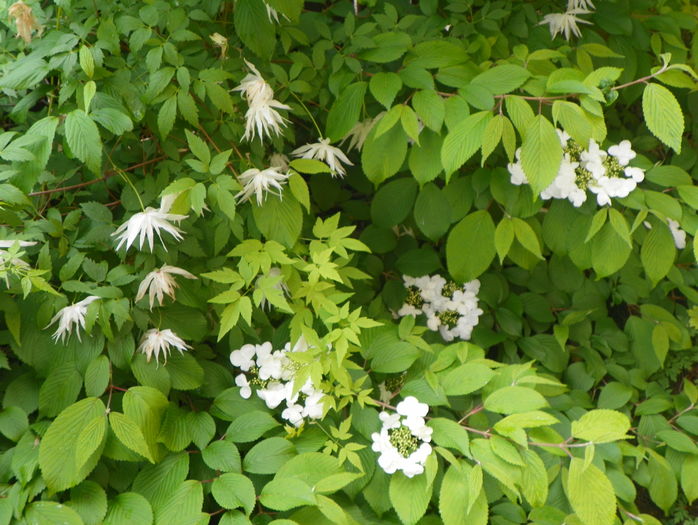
[{"left": 439, "top": 461, "right": 488, "bottom": 525}]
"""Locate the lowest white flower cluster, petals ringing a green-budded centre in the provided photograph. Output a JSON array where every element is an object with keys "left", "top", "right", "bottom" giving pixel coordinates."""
[{"left": 371, "top": 396, "right": 432, "bottom": 478}]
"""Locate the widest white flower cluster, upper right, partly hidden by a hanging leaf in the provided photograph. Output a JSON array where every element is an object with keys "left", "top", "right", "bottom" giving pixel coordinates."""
[{"left": 507, "top": 130, "right": 645, "bottom": 208}]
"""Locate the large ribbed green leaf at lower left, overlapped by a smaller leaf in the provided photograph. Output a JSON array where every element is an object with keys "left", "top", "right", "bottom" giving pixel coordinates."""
[{"left": 39, "top": 397, "right": 106, "bottom": 491}]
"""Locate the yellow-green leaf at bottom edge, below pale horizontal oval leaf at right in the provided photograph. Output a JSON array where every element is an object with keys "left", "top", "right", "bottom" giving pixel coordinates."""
[{"left": 566, "top": 458, "right": 616, "bottom": 525}]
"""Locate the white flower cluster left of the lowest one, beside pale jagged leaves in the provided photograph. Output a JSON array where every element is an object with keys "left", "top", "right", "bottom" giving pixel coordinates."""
[{"left": 230, "top": 339, "right": 324, "bottom": 427}]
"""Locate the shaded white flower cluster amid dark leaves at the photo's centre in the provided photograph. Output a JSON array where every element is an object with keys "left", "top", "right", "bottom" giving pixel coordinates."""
[{"left": 397, "top": 275, "right": 482, "bottom": 341}]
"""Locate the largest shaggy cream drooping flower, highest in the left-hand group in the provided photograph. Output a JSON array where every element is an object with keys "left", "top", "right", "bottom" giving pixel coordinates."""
[{"left": 233, "top": 60, "right": 291, "bottom": 140}]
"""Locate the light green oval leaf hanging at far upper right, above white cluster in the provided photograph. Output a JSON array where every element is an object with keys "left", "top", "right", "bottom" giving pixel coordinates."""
[{"left": 642, "top": 83, "right": 684, "bottom": 153}]
